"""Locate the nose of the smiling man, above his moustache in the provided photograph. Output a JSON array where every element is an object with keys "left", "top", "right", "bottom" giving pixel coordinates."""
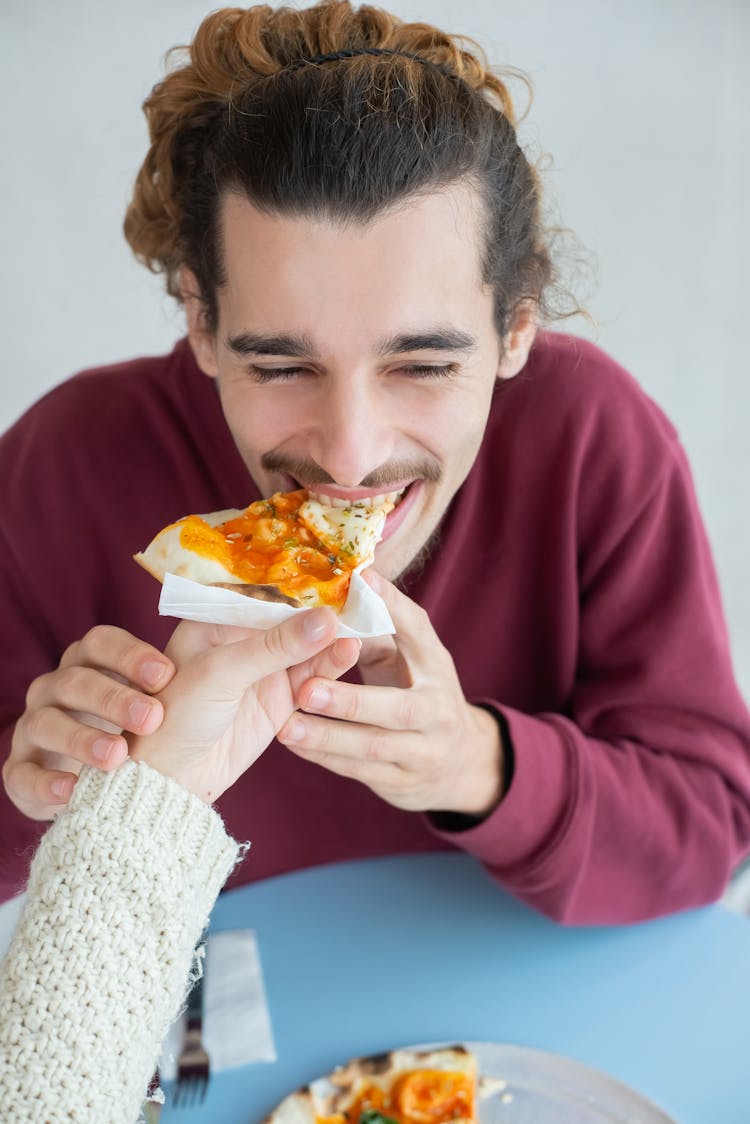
[{"left": 308, "top": 373, "right": 395, "bottom": 488}]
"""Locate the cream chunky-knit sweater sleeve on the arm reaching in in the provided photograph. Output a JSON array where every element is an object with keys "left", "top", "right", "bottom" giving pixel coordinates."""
[{"left": 0, "top": 761, "right": 240, "bottom": 1124}]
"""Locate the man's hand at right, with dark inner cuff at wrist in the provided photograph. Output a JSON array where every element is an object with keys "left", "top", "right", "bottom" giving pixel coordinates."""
[{"left": 278, "top": 570, "right": 503, "bottom": 816}]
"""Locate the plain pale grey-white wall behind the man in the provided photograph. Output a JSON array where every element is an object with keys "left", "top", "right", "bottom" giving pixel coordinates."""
[{"left": 0, "top": 0, "right": 750, "bottom": 695}]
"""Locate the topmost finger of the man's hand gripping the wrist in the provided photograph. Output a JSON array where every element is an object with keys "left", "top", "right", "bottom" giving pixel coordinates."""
[{"left": 60, "top": 625, "right": 174, "bottom": 692}]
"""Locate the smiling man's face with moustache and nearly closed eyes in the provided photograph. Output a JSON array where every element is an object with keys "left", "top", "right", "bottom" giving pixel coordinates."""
[{"left": 188, "top": 185, "right": 533, "bottom": 579}]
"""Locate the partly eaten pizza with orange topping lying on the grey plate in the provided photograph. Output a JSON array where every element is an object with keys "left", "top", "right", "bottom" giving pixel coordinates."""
[{"left": 264, "top": 1045, "right": 479, "bottom": 1124}]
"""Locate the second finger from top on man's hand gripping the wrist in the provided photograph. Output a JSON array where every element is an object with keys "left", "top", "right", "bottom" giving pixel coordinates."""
[{"left": 26, "top": 665, "right": 164, "bottom": 734}]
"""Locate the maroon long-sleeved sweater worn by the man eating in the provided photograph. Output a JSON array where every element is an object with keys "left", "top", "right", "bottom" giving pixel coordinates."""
[{"left": 0, "top": 334, "right": 750, "bottom": 922}]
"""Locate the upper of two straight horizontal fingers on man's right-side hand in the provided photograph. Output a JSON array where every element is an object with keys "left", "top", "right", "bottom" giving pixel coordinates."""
[{"left": 298, "top": 678, "right": 427, "bottom": 732}]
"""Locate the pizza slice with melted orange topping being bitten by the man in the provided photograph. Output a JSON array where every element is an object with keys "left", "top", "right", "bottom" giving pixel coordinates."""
[{"left": 134, "top": 489, "right": 394, "bottom": 613}]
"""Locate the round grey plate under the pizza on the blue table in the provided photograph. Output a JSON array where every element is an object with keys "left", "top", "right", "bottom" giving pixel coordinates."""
[{"left": 314, "top": 1042, "right": 677, "bottom": 1124}]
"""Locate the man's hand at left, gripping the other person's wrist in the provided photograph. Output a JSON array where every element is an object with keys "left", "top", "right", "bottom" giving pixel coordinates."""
[{"left": 2, "top": 625, "right": 174, "bottom": 819}]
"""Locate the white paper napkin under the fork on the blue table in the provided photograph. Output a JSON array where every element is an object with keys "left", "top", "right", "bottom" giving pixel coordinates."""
[{"left": 159, "top": 928, "right": 277, "bottom": 1081}]
